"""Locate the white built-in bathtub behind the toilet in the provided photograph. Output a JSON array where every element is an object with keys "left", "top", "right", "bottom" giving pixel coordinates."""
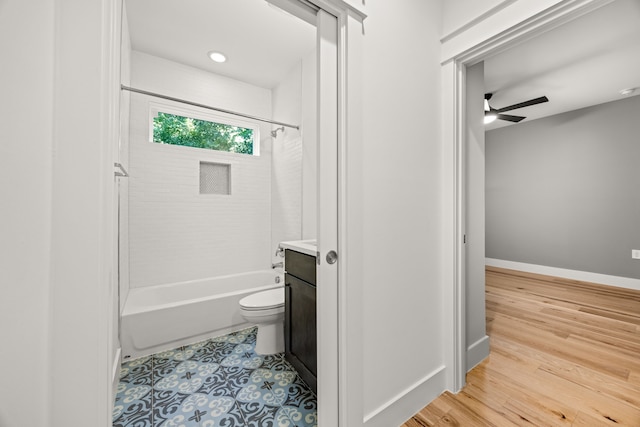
[{"left": 120, "top": 270, "right": 284, "bottom": 360}]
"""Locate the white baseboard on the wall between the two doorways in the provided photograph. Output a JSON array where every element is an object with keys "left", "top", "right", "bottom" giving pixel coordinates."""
[{"left": 364, "top": 366, "right": 446, "bottom": 427}]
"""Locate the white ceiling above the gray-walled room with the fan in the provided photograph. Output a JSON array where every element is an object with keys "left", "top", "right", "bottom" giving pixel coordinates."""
[{"left": 485, "top": 0, "right": 640, "bottom": 130}]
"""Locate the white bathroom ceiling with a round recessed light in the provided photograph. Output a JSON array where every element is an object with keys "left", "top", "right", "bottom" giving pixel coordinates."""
[{"left": 125, "top": 0, "right": 316, "bottom": 89}]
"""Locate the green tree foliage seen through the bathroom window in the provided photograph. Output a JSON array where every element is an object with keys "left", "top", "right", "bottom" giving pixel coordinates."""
[{"left": 153, "top": 112, "right": 253, "bottom": 154}]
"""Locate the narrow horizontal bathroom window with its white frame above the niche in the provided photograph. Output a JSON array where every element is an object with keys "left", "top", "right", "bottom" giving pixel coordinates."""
[{"left": 150, "top": 107, "right": 259, "bottom": 155}]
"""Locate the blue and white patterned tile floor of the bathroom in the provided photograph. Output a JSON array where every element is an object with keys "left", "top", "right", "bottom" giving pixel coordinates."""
[{"left": 113, "top": 328, "right": 318, "bottom": 427}]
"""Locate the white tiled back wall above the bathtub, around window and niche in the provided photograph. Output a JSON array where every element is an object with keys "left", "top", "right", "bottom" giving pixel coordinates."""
[{"left": 129, "top": 52, "right": 272, "bottom": 288}]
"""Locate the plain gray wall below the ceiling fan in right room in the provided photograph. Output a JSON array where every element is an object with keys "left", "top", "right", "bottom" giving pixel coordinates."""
[{"left": 486, "top": 96, "right": 640, "bottom": 279}]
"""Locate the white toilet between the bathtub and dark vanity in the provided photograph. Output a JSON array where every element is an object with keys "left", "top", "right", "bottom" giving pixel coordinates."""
[{"left": 240, "top": 287, "right": 284, "bottom": 355}]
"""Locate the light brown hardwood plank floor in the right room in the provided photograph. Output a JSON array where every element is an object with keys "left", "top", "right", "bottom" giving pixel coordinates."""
[{"left": 402, "top": 267, "right": 640, "bottom": 427}]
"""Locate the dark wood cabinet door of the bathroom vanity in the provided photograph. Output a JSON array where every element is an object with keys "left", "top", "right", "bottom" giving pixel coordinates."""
[{"left": 285, "top": 275, "right": 318, "bottom": 379}]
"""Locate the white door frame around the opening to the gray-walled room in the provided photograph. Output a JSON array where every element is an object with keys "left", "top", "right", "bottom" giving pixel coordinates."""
[{"left": 441, "top": 0, "right": 613, "bottom": 392}]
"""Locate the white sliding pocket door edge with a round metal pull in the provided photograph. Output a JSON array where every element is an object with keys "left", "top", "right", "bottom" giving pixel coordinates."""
[{"left": 316, "top": 10, "right": 340, "bottom": 426}]
